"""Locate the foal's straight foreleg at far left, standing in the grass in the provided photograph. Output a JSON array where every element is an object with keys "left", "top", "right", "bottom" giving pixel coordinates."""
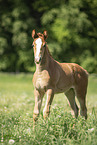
[{"left": 33, "top": 89, "right": 43, "bottom": 124}]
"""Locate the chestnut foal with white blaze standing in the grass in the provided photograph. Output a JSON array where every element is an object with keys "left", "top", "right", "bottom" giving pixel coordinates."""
[{"left": 32, "top": 30, "right": 88, "bottom": 122}]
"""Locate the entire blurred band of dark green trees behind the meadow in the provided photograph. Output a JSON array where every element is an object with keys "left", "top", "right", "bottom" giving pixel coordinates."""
[{"left": 0, "top": 0, "right": 97, "bottom": 73}]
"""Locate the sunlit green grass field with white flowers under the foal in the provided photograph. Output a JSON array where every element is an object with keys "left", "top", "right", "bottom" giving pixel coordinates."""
[{"left": 0, "top": 73, "right": 97, "bottom": 145}]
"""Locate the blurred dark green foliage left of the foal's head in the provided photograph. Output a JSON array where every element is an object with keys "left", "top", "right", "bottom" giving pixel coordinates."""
[{"left": 0, "top": 1, "right": 36, "bottom": 72}]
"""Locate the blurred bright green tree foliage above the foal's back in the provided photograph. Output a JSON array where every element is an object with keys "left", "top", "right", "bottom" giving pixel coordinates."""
[{"left": 42, "top": 0, "right": 97, "bottom": 73}]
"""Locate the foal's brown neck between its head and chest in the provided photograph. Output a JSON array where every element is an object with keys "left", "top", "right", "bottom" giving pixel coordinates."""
[{"left": 36, "top": 46, "right": 52, "bottom": 72}]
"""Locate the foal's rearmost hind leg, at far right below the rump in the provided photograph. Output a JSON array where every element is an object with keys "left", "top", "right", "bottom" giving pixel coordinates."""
[{"left": 76, "top": 86, "right": 87, "bottom": 119}]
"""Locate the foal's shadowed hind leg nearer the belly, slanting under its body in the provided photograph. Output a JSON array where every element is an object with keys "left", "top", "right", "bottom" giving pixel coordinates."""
[{"left": 65, "top": 88, "right": 79, "bottom": 118}]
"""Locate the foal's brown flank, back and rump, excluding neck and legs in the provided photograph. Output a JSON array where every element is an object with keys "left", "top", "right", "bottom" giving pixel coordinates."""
[{"left": 56, "top": 63, "right": 88, "bottom": 91}]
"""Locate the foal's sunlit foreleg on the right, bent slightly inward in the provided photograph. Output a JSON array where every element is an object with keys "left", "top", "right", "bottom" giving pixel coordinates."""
[{"left": 43, "top": 89, "right": 54, "bottom": 119}]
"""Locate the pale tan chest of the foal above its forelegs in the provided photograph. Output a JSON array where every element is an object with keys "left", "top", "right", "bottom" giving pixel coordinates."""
[{"left": 33, "top": 71, "right": 50, "bottom": 90}]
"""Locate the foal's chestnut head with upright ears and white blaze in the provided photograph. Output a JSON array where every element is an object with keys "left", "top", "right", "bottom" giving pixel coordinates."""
[{"left": 32, "top": 30, "right": 47, "bottom": 63}]
